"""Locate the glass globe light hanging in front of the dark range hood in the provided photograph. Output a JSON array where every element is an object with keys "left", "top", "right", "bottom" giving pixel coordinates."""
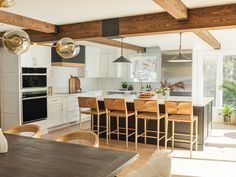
[{"left": 55, "top": 38, "right": 80, "bottom": 59}]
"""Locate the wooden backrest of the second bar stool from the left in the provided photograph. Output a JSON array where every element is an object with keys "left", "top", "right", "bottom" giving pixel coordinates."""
[{"left": 104, "top": 98, "right": 127, "bottom": 112}]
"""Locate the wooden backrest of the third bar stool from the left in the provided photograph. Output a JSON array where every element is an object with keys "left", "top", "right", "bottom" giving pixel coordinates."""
[{"left": 134, "top": 99, "right": 159, "bottom": 113}]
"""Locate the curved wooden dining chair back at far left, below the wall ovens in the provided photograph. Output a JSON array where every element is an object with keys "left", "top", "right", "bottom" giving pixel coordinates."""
[{"left": 4, "top": 124, "right": 41, "bottom": 138}]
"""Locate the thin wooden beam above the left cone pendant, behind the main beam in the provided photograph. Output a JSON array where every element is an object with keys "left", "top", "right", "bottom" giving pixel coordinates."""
[{"left": 86, "top": 37, "right": 145, "bottom": 52}]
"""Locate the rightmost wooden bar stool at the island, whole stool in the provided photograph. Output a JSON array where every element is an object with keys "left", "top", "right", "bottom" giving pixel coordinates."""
[{"left": 165, "top": 101, "right": 198, "bottom": 158}]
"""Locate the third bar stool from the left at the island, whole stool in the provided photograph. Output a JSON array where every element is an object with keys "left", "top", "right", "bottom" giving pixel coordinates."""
[{"left": 134, "top": 99, "right": 165, "bottom": 149}]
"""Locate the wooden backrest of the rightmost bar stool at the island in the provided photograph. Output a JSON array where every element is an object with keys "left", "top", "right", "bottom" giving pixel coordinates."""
[{"left": 165, "top": 101, "right": 193, "bottom": 116}]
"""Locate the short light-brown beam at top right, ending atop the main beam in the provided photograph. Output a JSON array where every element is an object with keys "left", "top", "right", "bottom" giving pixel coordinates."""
[{"left": 153, "top": 0, "right": 188, "bottom": 20}]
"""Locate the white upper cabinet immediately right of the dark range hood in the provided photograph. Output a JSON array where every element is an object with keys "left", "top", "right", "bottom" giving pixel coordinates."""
[{"left": 85, "top": 47, "right": 100, "bottom": 78}]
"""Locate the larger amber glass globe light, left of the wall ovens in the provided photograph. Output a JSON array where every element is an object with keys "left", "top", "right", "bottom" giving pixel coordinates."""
[{"left": 0, "top": 30, "right": 30, "bottom": 55}]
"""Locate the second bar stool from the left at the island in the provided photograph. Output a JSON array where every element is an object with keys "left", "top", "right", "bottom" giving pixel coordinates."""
[{"left": 104, "top": 98, "right": 135, "bottom": 148}]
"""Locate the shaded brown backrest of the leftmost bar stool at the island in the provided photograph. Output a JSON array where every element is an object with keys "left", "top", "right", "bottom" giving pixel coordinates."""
[{"left": 78, "top": 97, "right": 98, "bottom": 110}]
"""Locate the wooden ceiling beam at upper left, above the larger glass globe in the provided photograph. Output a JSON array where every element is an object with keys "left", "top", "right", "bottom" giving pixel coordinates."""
[{"left": 0, "top": 10, "right": 57, "bottom": 33}]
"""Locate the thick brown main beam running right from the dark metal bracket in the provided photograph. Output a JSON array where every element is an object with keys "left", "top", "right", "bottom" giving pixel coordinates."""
[{"left": 119, "top": 4, "right": 236, "bottom": 37}]
